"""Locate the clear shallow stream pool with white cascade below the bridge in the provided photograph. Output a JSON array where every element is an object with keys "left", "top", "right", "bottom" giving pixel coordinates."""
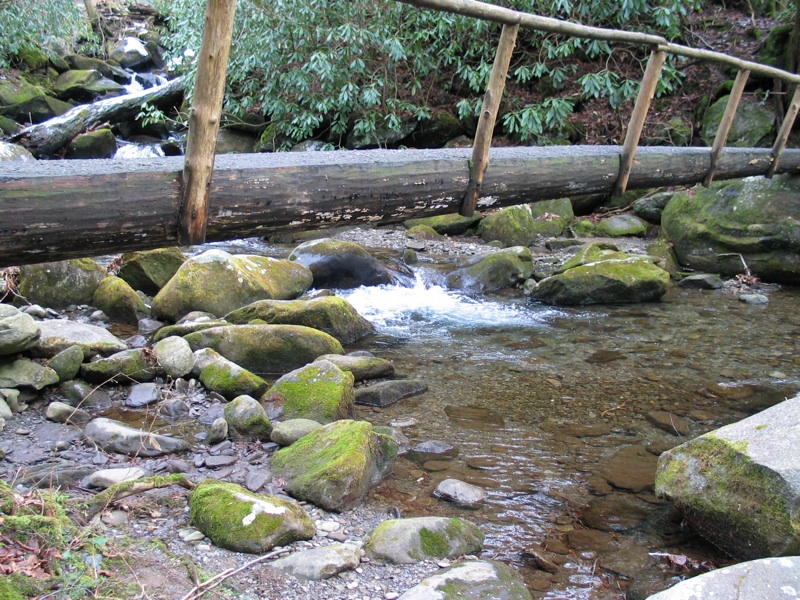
[{"left": 208, "top": 238, "right": 800, "bottom": 599}]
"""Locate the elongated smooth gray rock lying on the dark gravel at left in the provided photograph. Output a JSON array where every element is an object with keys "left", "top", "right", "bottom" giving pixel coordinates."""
[{"left": 83, "top": 418, "right": 189, "bottom": 456}]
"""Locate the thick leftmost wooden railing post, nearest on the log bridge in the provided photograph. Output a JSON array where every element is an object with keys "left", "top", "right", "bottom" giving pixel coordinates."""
[{"left": 178, "top": 0, "right": 236, "bottom": 244}]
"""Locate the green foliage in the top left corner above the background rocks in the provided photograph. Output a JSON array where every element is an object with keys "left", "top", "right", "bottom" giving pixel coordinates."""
[{"left": 0, "top": 0, "right": 92, "bottom": 68}]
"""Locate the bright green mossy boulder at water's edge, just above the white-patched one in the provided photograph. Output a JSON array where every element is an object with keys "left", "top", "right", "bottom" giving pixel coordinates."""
[{"left": 270, "top": 421, "right": 397, "bottom": 512}]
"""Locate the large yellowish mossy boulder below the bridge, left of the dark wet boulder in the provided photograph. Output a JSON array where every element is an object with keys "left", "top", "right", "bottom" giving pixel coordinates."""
[{"left": 152, "top": 250, "right": 312, "bottom": 321}]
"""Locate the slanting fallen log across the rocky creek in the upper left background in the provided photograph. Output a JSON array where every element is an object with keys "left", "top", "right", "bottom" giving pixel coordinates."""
[{"left": 8, "top": 77, "right": 186, "bottom": 157}]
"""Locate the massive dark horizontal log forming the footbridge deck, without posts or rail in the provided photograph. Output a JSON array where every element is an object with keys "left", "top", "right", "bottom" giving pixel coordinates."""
[{"left": 0, "top": 146, "right": 800, "bottom": 267}]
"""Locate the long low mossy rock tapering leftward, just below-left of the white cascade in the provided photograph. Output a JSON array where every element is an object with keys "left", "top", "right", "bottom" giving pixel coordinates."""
[{"left": 225, "top": 296, "right": 375, "bottom": 344}]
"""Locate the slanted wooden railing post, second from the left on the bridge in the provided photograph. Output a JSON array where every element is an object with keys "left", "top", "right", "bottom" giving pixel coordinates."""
[{"left": 459, "top": 25, "right": 519, "bottom": 217}]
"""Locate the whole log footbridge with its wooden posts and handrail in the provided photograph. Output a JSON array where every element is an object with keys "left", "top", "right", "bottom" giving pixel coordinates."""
[{"left": 0, "top": 0, "right": 800, "bottom": 267}]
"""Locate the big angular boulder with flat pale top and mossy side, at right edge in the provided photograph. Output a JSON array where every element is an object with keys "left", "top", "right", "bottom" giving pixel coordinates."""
[{"left": 656, "top": 396, "right": 800, "bottom": 560}]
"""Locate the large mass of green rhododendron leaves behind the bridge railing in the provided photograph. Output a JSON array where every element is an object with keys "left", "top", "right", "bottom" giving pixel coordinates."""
[{"left": 157, "top": 0, "right": 697, "bottom": 147}]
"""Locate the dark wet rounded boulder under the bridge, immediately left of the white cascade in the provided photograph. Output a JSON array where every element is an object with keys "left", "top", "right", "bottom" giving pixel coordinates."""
[{"left": 289, "top": 238, "right": 393, "bottom": 289}]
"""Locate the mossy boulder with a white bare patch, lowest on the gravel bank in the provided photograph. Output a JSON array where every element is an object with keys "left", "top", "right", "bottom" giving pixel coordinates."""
[{"left": 189, "top": 479, "right": 316, "bottom": 554}]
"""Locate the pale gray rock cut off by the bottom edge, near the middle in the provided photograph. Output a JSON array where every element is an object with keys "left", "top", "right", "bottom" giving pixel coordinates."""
[{"left": 398, "top": 560, "right": 532, "bottom": 600}]
